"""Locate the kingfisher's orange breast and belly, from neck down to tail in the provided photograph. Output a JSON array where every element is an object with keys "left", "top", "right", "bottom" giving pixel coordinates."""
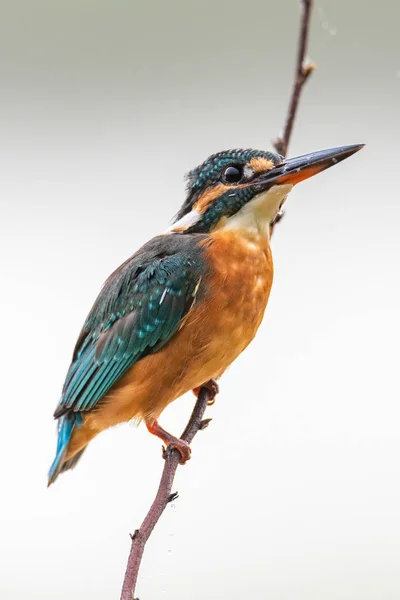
[{"left": 70, "top": 229, "right": 273, "bottom": 456}]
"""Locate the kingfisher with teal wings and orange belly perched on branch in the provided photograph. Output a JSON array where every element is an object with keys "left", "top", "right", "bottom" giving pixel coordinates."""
[{"left": 48, "top": 144, "right": 363, "bottom": 485}]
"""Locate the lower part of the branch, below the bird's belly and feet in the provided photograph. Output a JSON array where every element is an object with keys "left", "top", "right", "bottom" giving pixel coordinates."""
[{"left": 121, "top": 387, "right": 211, "bottom": 600}]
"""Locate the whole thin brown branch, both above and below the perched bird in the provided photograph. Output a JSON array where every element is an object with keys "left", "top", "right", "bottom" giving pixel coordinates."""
[{"left": 121, "top": 0, "right": 315, "bottom": 600}]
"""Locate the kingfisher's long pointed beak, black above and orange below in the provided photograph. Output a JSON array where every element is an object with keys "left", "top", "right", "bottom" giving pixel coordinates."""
[{"left": 258, "top": 144, "right": 364, "bottom": 187}]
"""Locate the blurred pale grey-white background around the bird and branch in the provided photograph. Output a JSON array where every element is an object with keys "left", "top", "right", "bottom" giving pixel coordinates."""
[{"left": 0, "top": 0, "right": 400, "bottom": 600}]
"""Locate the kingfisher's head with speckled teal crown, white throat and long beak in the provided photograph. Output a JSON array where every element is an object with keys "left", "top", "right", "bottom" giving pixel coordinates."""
[{"left": 170, "top": 144, "right": 363, "bottom": 233}]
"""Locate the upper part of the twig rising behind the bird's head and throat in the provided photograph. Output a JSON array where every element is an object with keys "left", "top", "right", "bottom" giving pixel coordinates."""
[{"left": 270, "top": 0, "right": 316, "bottom": 235}]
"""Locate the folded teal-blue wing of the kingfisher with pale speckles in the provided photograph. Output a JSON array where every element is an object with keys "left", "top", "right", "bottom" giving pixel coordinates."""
[{"left": 55, "top": 235, "right": 204, "bottom": 418}]
